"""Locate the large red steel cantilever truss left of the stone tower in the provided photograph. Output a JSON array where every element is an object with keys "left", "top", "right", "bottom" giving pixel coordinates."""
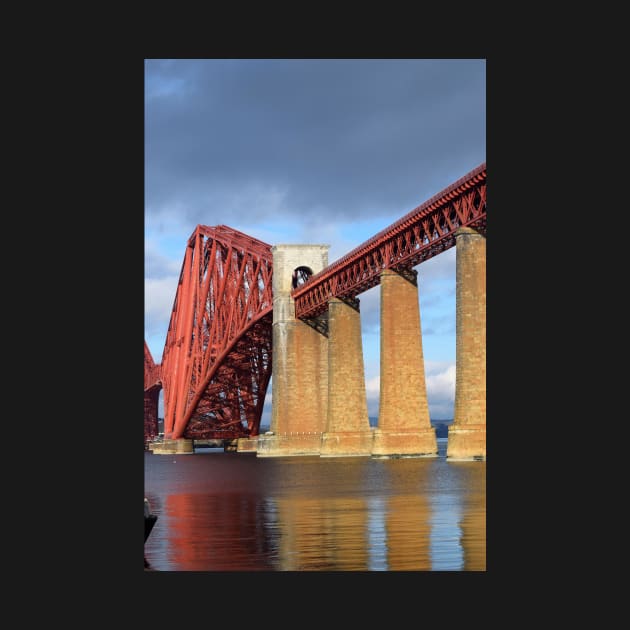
[{"left": 161, "top": 225, "right": 273, "bottom": 439}]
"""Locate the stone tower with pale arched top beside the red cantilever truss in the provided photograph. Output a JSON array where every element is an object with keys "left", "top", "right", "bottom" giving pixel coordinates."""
[{"left": 257, "top": 245, "right": 328, "bottom": 457}]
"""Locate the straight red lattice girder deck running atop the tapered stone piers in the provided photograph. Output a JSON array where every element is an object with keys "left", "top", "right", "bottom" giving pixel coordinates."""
[{"left": 291, "top": 162, "right": 486, "bottom": 319}]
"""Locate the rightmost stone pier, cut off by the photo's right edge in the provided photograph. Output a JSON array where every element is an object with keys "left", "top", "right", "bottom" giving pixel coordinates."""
[{"left": 446, "top": 228, "right": 486, "bottom": 459}]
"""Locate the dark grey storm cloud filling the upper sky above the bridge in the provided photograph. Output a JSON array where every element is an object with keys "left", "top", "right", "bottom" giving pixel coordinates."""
[{"left": 145, "top": 60, "right": 486, "bottom": 224}]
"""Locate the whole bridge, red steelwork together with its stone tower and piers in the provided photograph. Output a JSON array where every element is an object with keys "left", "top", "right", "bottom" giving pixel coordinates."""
[{"left": 145, "top": 163, "right": 486, "bottom": 459}]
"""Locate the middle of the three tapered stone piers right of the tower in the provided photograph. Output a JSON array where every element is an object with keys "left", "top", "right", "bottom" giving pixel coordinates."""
[{"left": 372, "top": 269, "right": 437, "bottom": 457}]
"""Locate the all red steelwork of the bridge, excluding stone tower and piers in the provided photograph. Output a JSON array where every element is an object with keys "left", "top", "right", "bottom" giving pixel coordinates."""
[{"left": 144, "top": 163, "right": 486, "bottom": 460}]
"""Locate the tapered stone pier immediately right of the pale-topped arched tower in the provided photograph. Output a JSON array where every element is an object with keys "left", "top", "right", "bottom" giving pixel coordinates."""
[{"left": 320, "top": 298, "right": 372, "bottom": 457}]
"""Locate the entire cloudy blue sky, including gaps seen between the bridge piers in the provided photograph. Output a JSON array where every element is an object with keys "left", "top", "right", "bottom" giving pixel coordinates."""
[{"left": 144, "top": 59, "right": 486, "bottom": 425}]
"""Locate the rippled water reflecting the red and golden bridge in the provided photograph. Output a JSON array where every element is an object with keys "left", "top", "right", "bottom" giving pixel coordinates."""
[{"left": 144, "top": 438, "right": 486, "bottom": 571}]
